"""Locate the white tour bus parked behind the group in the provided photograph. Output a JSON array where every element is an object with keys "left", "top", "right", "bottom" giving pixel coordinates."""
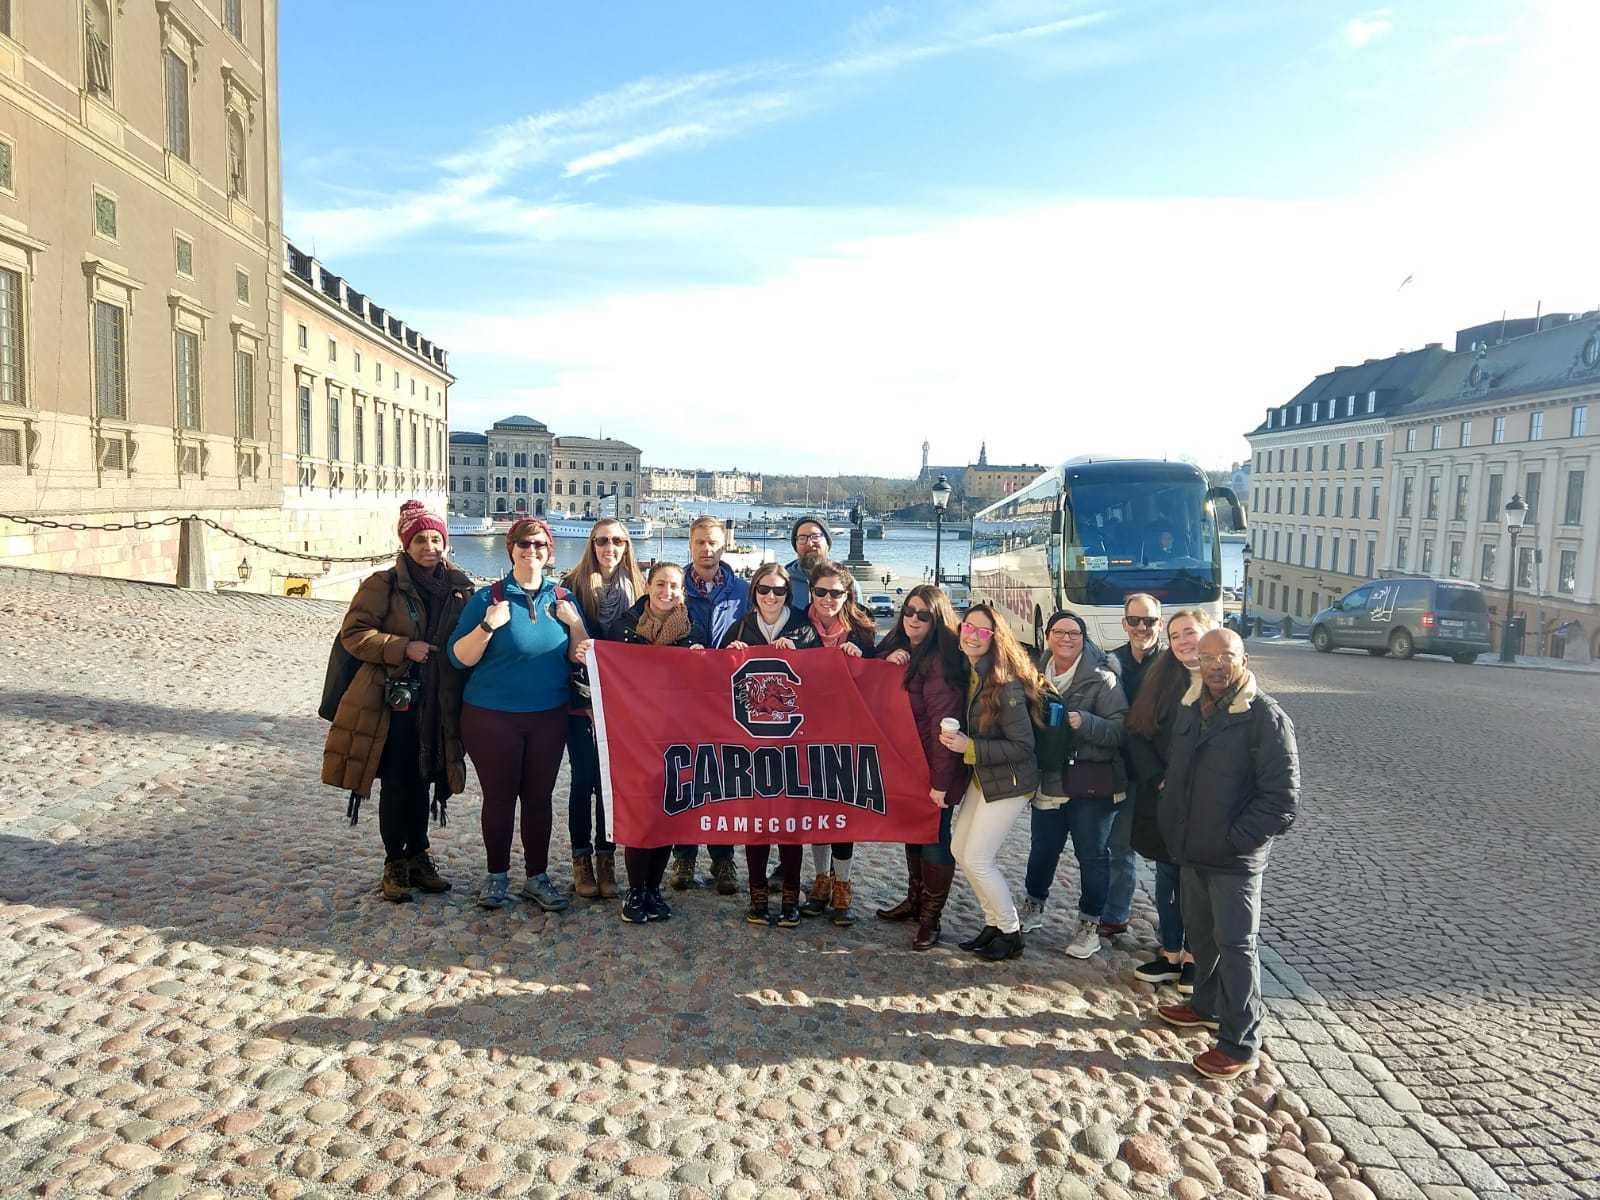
[{"left": 971, "top": 458, "right": 1245, "bottom": 650}]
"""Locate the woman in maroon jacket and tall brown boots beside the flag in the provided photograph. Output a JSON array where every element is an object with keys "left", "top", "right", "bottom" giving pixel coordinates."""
[{"left": 877, "top": 584, "right": 971, "bottom": 950}]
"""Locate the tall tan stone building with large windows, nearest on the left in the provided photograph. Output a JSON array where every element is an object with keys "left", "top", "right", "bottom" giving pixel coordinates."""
[{"left": 0, "top": 0, "right": 282, "bottom": 582}]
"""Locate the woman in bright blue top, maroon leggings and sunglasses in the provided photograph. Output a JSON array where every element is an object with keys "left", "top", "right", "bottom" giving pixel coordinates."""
[{"left": 450, "top": 517, "right": 584, "bottom": 912}]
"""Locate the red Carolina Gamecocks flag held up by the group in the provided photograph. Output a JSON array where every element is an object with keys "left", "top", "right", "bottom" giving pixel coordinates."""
[{"left": 589, "top": 642, "right": 939, "bottom": 848}]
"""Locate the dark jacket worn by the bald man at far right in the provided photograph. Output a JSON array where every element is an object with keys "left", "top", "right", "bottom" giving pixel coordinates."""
[{"left": 1157, "top": 674, "right": 1299, "bottom": 875}]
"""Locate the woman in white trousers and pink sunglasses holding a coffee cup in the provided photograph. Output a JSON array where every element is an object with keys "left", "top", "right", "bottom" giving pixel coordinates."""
[{"left": 939, "top": 603, "right": 1040, "bottom": 962}]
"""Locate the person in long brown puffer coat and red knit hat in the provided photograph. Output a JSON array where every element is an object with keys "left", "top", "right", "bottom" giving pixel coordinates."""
[{"left": 322, "top": 501, "right": 472, "bottom": 901}]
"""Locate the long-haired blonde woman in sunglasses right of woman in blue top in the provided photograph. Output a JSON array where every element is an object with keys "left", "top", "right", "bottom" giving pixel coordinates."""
[{"left": 562, "top": 517, "right": 645, "bottom": 899}]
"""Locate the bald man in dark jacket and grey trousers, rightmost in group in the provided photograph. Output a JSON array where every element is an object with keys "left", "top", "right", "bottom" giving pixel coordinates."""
[{"left": 1155, "top": 629, "right": 1299, "bottom": 1078}]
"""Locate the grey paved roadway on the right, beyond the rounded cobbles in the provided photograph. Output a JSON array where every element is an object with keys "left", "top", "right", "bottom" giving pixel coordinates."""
[{"left": 1253, "top": 646, "right": 1600, "bottom": 1200}]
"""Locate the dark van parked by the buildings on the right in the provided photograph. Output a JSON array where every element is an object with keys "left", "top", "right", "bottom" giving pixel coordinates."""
[{"left": 1310, "top": 576, "right": 1491, "bottom": 662}]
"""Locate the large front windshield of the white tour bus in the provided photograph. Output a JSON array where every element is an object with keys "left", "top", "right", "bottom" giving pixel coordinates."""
[{"left": 1062, "top": 475, "right": 1221, "bottom": 605}]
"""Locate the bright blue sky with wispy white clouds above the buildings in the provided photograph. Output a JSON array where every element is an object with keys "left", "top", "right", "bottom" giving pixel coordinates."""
[{"left": 280, "top": 0, "right": 1600, "bottom": 474}]
